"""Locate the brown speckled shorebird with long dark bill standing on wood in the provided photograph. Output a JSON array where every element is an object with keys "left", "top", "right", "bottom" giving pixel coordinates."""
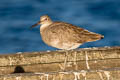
[{"left": 31, "top": 15, "right": 104, "bottom": 50}]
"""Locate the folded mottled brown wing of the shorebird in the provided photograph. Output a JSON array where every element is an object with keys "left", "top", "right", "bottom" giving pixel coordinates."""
[{"left": 48, "top": 22, "right": 100, "bottom": 43}]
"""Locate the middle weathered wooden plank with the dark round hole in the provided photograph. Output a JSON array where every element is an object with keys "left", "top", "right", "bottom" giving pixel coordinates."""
[{"left": 0, "top": 59, "right": 120, "bottom": 74}]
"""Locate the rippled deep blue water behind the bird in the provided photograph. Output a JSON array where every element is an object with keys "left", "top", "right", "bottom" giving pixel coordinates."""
[{"left": 0, "top": 0, "right": 120, "bottom": 54}]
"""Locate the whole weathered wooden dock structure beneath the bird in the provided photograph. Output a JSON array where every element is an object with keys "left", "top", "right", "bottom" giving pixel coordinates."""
[{"left": 0, "top": 47, "right": 120, "bottom": 80}]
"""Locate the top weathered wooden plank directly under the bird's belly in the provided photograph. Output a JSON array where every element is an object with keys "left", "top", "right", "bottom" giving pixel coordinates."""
[{"left": 0, "top": 47, "right": 120, "bottom": 67}]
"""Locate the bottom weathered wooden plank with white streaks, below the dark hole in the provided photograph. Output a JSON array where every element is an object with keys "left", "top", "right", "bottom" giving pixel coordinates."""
[{"left": 0, "top": 70, "right": 120, "bottom": 80}]
